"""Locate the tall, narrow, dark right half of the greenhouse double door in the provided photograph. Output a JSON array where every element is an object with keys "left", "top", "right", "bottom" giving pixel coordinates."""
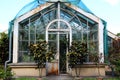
[{"left": 59, "top": 34, "right": 69, "bottom": 74}]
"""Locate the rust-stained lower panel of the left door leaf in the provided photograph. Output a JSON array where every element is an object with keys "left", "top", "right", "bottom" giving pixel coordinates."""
[{"left": 46, "top": 61, "right": 58, "bottom": 75}]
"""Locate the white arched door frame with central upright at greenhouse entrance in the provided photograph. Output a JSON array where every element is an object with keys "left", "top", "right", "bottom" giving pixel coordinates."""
[{"left": 45, "top": 19, "right": 72, "bottom": 74}]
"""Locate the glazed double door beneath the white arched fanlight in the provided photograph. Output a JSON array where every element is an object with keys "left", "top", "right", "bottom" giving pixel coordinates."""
[{"left": 48, "top": 32, "right": 69, "bottom": 74}]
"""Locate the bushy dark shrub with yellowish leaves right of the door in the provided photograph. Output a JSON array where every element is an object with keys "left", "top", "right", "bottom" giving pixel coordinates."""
[{"left": 67, "top": 41, "right": 87, "bottom": 67}]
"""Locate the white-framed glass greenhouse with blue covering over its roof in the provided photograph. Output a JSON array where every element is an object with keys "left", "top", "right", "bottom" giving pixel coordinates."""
[{"left": 9, "top": 0, "right": 107, "bottom": 76}]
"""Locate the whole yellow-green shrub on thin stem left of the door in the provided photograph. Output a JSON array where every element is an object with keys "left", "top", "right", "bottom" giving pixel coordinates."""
[{"left": 29, "top": 41, "right": 56, "bottom": 77}]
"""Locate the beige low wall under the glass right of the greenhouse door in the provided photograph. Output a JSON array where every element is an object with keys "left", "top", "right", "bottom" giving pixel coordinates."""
[{"left": 68, "top": 64, "right": 105, "bottom": 76}]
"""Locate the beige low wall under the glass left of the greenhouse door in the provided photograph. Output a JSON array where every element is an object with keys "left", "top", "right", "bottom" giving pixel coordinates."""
[{"left": 9, "top": 63, "right": 46, "bottom": 77}]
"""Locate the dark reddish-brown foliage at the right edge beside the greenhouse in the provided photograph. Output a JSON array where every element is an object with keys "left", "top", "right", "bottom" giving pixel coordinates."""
[{"left": 109, "top": 39, "right": 120, "bottom": 76}]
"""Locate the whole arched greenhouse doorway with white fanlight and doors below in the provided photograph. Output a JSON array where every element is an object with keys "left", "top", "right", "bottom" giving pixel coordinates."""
[{"left": 46, "top": 19, "right": 72, "bottom": 74}]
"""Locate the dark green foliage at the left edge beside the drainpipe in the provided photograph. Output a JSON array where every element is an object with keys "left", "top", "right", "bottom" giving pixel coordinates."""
[{"left": 0, "top": 33, "right": 9, "bottom": 64}]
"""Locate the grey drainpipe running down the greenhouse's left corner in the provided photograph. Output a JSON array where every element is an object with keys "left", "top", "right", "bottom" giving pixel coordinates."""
[{"left": 5, "top": 21, "right": 13, "bottom": 72}]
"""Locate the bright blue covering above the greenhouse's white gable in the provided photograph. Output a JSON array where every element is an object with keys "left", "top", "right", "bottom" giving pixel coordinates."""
[{"left": 15, "top": 0, "right": 93, "bottom": 18}]
